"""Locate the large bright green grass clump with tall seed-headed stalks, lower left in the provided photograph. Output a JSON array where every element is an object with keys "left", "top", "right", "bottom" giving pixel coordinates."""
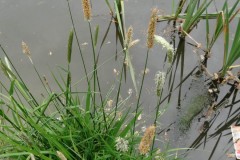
[{"left": 0, "top": 0, "right": 181, "bottom": 160}]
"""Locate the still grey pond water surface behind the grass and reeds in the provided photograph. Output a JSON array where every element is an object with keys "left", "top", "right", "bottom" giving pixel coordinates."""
[{"left": 0, "top": 0, "right": 240, "bottom": 160}]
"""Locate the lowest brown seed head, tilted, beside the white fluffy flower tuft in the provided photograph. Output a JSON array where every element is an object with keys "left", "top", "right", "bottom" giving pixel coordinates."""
[{"left": 138, "top": 125, "right": 156, "bottom": 155}]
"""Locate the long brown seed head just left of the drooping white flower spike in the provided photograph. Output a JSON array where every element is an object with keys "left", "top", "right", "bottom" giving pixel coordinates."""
[{"left": 147, "top": 8, "right": 158, "bottom": 48}]
